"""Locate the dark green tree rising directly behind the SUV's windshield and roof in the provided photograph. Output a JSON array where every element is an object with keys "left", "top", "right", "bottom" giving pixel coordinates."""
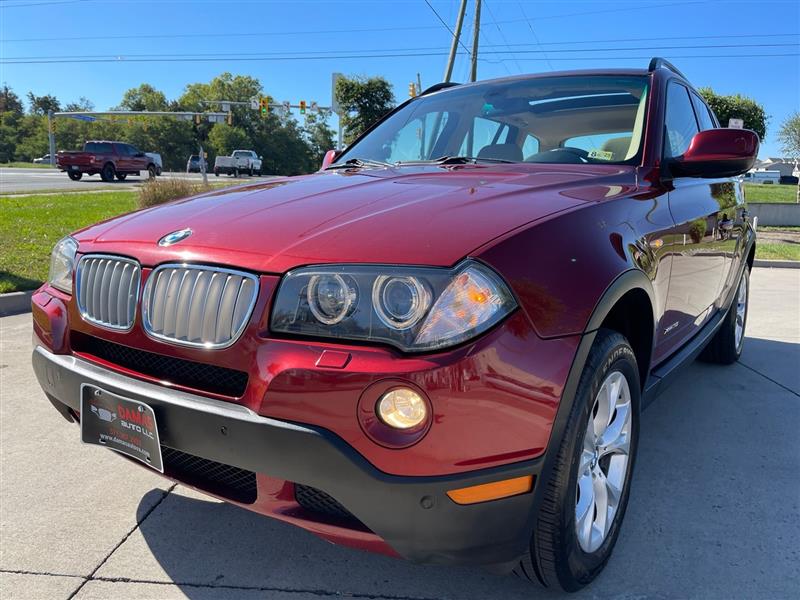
[{"left": 334, "top": 77, "right": 394, "bottom": 144}]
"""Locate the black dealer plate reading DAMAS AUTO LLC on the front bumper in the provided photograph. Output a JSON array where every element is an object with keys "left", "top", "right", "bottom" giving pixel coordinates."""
[{"left": 81, "top": 384, "right": 164, "bottom": 473}]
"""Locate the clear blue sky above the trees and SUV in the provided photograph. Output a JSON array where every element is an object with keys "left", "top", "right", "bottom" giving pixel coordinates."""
[{"left": 0, "top": 0, "right": 800, "bottom": 156}]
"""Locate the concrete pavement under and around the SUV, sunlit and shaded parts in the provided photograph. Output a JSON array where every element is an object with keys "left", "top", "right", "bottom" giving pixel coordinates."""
[{"left": 0, "top": 269, "right": 800, "bottom": 600}]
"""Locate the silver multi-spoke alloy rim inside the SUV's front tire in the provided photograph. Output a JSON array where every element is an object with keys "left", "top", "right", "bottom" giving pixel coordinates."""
[{"left": 575, "top": 371, "right": 633, "bottom": 552}]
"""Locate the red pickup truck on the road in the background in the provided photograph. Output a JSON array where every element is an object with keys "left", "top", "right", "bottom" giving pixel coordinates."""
[{"left": 56, "top": 141, "right": 158, "bottom": 181}]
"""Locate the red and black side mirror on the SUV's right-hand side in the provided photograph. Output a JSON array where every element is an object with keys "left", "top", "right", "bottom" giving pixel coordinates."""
[{"left": 669, "top": 129, "right": 758, "bottom": 178}]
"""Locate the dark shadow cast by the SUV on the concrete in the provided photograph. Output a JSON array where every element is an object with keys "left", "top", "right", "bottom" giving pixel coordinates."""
[{"left": 138, "top": 339, "right": 800, "bottom": 600}]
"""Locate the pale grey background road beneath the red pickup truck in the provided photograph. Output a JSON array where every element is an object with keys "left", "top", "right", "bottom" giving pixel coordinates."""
[{"left": 0, "top": 168, "right": 269, "bottom": 194}]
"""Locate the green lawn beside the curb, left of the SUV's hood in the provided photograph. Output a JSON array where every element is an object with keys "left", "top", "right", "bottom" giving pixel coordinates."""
[{"left": 0, "top": 191, "right": 138, "bottom": 293}]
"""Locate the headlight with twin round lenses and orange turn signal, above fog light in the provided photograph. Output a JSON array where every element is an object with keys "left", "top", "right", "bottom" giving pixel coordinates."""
[{"left": 271, "top": 260, "right": 517, "bottom": 352}]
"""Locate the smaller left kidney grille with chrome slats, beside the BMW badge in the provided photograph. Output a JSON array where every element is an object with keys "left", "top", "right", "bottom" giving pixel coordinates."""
[{"left": 75, "top": 254, "right": 141, "bottom": 330}]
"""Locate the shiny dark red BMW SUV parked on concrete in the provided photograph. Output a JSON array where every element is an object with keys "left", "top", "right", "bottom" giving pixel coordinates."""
[{"left": 33, "top": 59, "right": 758, "bottom": 590}]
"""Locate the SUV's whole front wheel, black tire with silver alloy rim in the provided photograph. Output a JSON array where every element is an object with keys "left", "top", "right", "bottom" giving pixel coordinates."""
[{"left": 514, "top": 329, "right": 641, "bottom": 592}]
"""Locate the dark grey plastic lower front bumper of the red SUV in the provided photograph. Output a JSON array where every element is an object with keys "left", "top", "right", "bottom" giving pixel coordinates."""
[{"left": 33, "top": 346, "right": 545, "bottom": 565}]
